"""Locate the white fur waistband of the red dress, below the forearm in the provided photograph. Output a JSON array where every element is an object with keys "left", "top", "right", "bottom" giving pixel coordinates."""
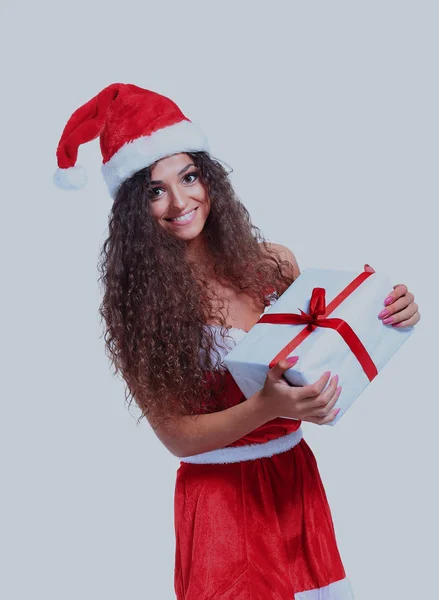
[{"left": 179, "top": 427, "right": 303, "bottom": 464}]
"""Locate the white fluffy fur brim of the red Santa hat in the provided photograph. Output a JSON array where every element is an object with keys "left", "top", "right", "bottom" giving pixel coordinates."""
[{"left": 101, "top": 121, "right": 209, "bottom": 198}]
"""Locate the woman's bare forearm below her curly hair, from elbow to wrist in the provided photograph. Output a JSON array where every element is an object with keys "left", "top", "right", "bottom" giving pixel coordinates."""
[{"left": 147, "top": 391, "right": 272, "bottom": 457}]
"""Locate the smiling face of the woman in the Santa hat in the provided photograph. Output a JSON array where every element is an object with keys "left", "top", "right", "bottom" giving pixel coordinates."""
[{"left": 151, "top": 153, "right": 210, "bottom": 241}]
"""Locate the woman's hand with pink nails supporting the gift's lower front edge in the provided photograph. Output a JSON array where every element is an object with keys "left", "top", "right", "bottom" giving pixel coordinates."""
[{"left": 260, "top": 359, "right": 341, "bottom": 425}]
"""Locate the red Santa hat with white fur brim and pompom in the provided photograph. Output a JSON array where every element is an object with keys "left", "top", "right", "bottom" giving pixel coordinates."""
[{"left": 54, "top": 83, "right": 209, "bottom": 198}]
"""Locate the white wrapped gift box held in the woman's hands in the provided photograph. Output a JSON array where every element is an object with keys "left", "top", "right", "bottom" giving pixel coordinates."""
[{"left": 224, "top": 268, "right": 414, "bottom": 425}]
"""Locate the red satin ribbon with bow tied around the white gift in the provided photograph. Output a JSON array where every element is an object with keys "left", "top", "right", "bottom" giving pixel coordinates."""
[{"left": 258, "top": 272, "right": 378, "bottom": 381}]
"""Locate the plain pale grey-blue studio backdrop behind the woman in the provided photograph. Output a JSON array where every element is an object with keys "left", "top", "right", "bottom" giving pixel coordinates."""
[{"left": 0, "top": 0, "right": 439, "bottom": 600}]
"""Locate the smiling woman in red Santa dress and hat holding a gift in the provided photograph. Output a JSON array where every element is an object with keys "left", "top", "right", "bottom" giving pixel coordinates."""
[{"left": 55, "top": 84, "right": 419, "bottom": 600}]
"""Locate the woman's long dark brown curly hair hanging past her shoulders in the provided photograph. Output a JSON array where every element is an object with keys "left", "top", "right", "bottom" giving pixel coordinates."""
[{"left": 98, "top": 152, "right": 294, "bottom": 428}]
